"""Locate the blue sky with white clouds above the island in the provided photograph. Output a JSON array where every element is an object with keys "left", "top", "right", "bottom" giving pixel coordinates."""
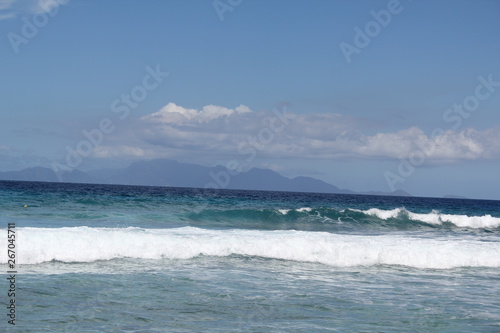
[{"left": 0, "top": 0, "right": 500, "bottom": 200}]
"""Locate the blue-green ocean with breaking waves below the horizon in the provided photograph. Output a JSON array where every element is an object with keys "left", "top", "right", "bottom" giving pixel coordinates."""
[{"left": 0, "top": 181, "right": 500, "bottom": 332}]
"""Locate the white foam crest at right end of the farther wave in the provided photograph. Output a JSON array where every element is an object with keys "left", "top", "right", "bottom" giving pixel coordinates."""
[{"left": 351, "top": 208, "right": 500, "bottom": 228}]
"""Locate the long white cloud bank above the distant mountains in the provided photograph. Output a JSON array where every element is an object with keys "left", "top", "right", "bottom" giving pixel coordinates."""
[{"left": 90, "top": 103, "right": 500, "bottom": 163}]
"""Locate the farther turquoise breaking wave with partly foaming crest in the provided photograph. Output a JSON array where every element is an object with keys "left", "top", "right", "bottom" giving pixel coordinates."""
[{"left": 189, "top": 207, "right": 500, "bottom": 231}]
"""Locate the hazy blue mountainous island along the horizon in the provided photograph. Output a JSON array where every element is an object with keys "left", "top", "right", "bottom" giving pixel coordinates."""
[{"left": 0, "top": 159, "right": 411, "bottom": 196}]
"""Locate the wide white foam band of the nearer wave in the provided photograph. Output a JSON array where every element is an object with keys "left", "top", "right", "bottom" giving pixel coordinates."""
[{"left": 0, "top": 227, "right": 500, "bottom": 269}]
